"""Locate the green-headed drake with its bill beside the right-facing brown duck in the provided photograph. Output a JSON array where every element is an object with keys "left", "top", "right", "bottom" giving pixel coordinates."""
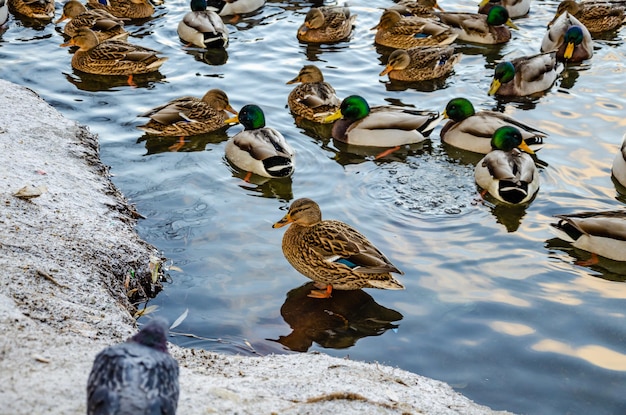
[{"left": 225, "top": 104, "right": 295, "bottom": 178}]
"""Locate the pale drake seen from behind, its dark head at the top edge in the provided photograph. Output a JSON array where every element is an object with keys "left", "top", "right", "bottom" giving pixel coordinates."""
[{"left": 177, "top": 0, "right": 228, "bottom": 48}]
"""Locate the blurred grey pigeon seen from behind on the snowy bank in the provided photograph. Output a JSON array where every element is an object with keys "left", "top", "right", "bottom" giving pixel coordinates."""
[{"left": 87, "top": 318, "right": 179, "bottom": 415}]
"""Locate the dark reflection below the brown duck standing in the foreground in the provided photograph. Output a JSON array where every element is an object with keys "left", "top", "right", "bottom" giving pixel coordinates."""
[{"left": 270, "top": 282, "right": 403, "bottom": 352}]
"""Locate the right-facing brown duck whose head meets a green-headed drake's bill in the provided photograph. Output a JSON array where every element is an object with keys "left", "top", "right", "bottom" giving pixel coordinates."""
[{"left": 137, "top": 89, "right": 237, "bottom": 137}]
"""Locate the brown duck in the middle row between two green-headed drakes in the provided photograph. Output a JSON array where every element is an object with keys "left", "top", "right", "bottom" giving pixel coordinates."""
[{"left": 287, "top": 65, "right": 341, "bottom": 123}]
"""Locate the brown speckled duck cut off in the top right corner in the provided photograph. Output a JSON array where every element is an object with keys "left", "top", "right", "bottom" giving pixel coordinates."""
[{"left": 548, "top": 0, "right": 624, "bottom": 33}]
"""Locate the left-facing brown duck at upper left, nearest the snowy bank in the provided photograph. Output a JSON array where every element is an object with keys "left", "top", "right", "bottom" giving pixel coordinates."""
[{"left": 61, "top": 27, "right": 167, "bottom": 77}]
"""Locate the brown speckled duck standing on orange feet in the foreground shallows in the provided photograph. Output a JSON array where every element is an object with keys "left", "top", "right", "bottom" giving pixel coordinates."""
[{"left": 273, "top": 198, "right": 404, "bottom": 298}]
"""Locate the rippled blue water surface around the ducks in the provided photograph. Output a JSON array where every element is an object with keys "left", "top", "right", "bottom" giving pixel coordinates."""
[{"left": 0, "top": 0, "right": 626, "bottom": 414}]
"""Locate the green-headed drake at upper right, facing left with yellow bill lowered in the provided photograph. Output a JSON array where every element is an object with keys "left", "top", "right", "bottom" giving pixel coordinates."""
[{"left": 487, "top": 51, "right": 563, "bottom": 97}]
